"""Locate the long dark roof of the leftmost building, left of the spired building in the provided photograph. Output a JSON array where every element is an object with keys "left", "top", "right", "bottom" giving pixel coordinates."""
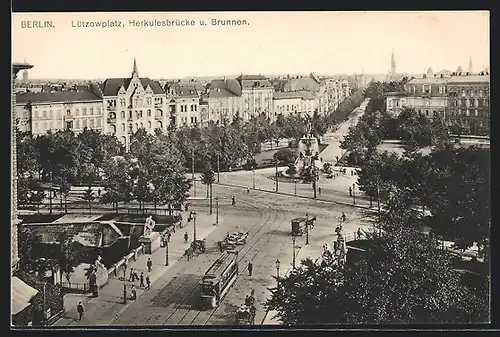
[{"left": 16, "top": 90, "right": 102, "bottom": 103}]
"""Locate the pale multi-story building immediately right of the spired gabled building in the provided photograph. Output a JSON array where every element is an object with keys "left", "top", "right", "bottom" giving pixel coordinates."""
[{"left": 165, "top": 82, "right": 201, "bottom": 127}]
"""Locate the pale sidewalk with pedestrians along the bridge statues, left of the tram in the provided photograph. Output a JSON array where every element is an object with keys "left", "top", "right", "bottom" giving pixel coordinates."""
[{"left": 53, "top": 214, "right": 221, "bottom": 326}]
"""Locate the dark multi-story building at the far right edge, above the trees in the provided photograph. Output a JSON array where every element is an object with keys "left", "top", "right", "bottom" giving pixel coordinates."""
[{"left": 446, "top": 74, "right": 490, "bottom": 135}]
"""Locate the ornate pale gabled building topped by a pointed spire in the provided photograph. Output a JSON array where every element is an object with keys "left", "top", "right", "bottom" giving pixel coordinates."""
[{"left": 100, "top": 59, "right": 170, "bottom": 149}]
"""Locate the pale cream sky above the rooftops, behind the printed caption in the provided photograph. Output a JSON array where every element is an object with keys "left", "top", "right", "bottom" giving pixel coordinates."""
[{"left": 12, "top": 11, "right": 490, "bottom": 79}]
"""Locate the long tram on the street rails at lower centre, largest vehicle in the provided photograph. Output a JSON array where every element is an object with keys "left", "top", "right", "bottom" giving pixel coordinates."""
[{"left": 201, "top": 250, "right": 238, "bottom": 309}]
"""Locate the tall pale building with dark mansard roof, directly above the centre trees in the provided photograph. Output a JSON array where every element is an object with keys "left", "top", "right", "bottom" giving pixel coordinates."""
[{"left": 236, "top": 75, "right": 274, "bottom": 121}]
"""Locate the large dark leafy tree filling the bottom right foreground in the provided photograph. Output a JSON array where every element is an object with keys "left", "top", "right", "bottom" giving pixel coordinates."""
[{"left": 266, "top": 197, "right": 488, "bottom": 325}]
